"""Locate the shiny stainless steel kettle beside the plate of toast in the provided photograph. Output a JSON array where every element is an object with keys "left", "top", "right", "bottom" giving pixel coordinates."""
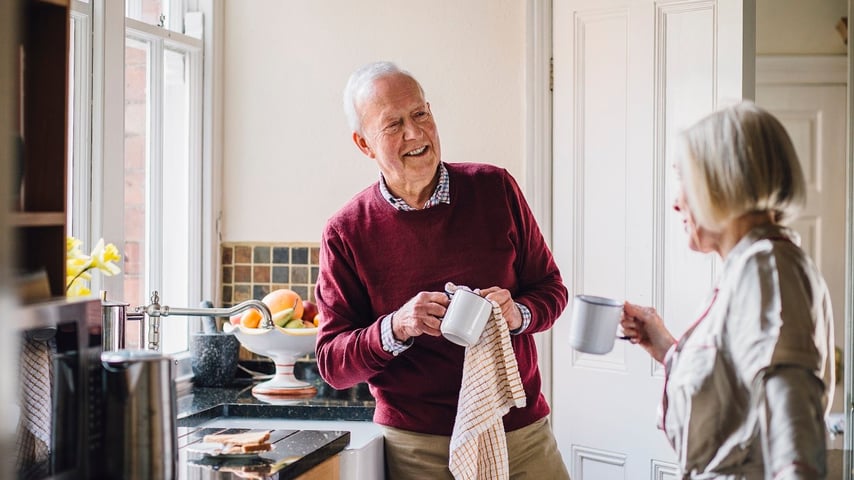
[{"left": 101, "top": 350, "right": 178, "bottom": 480}]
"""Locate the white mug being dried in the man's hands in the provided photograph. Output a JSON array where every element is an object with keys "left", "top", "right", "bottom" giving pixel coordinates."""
[{"left": 441, "top": 288, "right": 492, "bottom": 347}]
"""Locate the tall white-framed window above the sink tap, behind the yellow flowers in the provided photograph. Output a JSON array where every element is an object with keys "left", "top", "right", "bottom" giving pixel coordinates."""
[{"left": 68, "top": 0, "right": 210, "bottom": 353}]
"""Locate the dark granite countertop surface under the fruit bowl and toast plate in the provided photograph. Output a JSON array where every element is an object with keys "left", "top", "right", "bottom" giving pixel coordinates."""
[{"left": 177, "top": 357, "right": 375, "bottom": 479}]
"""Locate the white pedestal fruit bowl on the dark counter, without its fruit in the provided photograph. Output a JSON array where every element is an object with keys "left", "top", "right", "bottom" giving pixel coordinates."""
[{"left": 225, "top": 324, "right": 317, "bottom": 396}]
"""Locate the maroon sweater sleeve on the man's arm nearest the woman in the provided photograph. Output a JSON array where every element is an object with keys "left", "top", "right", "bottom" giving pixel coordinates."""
[{"left": 505, "top": 172, "right": 568, "bottom": 334}]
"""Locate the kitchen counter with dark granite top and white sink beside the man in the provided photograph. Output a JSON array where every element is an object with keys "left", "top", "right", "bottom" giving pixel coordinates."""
[{"left": 178, "top": 362, "right": 383, "bottom": 479}]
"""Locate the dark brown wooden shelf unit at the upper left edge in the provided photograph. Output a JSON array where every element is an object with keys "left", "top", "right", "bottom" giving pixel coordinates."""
[{"left": 9, "top": 0, "right": 70, "bottom": 297}]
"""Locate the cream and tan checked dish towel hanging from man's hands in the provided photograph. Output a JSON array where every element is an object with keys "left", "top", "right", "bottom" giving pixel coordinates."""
[{"left": 448, "top": 287, "right": 525, "bottom": 480}]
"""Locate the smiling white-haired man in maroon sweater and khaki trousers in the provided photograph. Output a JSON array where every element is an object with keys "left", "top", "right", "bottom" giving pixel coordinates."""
[{"left": 316, "top": 62, "right": 569, "bottom": 479}]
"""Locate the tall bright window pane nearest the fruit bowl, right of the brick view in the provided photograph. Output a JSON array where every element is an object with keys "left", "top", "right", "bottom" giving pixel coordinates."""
[{"left": 160, "top": 49, "right": 191, "bottom": 353}]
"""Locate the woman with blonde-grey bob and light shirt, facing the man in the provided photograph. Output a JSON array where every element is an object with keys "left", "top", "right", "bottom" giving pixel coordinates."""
[{"left": 621, "top": 102, "right": 834, "bottom": 480}]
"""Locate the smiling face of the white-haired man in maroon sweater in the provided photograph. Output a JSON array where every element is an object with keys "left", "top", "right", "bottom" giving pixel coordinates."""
[{"left": 353, "top": 75, "right": 441, "bottom": 188}]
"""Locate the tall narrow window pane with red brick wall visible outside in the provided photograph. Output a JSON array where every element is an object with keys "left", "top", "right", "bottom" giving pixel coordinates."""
[{"left": 122, "top": 38, "right": 151, "bottom": 314}]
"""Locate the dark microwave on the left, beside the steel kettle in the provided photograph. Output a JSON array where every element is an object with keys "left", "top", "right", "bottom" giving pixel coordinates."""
[{"left": 12, "top": 298, "right": 103, "bottom": 480}]
